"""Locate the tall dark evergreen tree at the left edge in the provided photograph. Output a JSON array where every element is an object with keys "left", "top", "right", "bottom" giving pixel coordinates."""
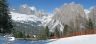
[{"left": 0, "top": 0, "right": 13, "bottom": 33}]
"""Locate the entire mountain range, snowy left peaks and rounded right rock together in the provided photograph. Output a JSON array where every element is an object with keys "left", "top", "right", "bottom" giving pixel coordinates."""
[{"left": 10, "top": 3, "right": 96, "bottom": 34}]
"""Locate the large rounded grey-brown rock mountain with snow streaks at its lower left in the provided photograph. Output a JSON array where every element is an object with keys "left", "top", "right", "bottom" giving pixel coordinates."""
[{"left": 48, "top": 3, "right": 85, "bottom": 31}]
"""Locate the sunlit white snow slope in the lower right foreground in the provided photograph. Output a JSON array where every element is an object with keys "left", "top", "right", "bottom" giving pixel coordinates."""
[{"left": 47, "top": 34, "right": 96, "bottom": 44}]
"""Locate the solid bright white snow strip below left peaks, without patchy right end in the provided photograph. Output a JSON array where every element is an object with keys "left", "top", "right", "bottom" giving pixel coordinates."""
[{"left": 11, "top": 12, "right": 40, "bottom": 21}]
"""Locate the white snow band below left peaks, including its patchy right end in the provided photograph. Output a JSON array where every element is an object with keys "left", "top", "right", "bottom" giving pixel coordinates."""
[{"left": 10, "top": 12, "right": 52, "bottom": 26}]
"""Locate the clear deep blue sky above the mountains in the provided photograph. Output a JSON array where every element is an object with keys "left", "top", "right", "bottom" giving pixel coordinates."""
[{"left": 8, "top": 0, "right": 96, "bottom": 12}]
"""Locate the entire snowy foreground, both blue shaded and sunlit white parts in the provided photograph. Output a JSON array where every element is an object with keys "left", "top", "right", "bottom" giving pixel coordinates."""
[{"left": 0, "top": 34, "right": 96, "bottom": 44}]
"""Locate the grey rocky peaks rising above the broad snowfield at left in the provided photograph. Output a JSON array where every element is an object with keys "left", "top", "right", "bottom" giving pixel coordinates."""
[{"left": 18, "top": 4, "right": 45, "bottom": 17}]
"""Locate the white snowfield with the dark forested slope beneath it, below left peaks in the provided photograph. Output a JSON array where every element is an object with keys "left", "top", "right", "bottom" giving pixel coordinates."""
[{"left": 9, "top": 12, "right": 51, "bottom": 34}]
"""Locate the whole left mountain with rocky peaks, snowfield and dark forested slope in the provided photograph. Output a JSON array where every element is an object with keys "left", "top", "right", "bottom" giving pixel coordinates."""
[{"left": 10, "top": 4, "right": 53, "bottom": 34}]
